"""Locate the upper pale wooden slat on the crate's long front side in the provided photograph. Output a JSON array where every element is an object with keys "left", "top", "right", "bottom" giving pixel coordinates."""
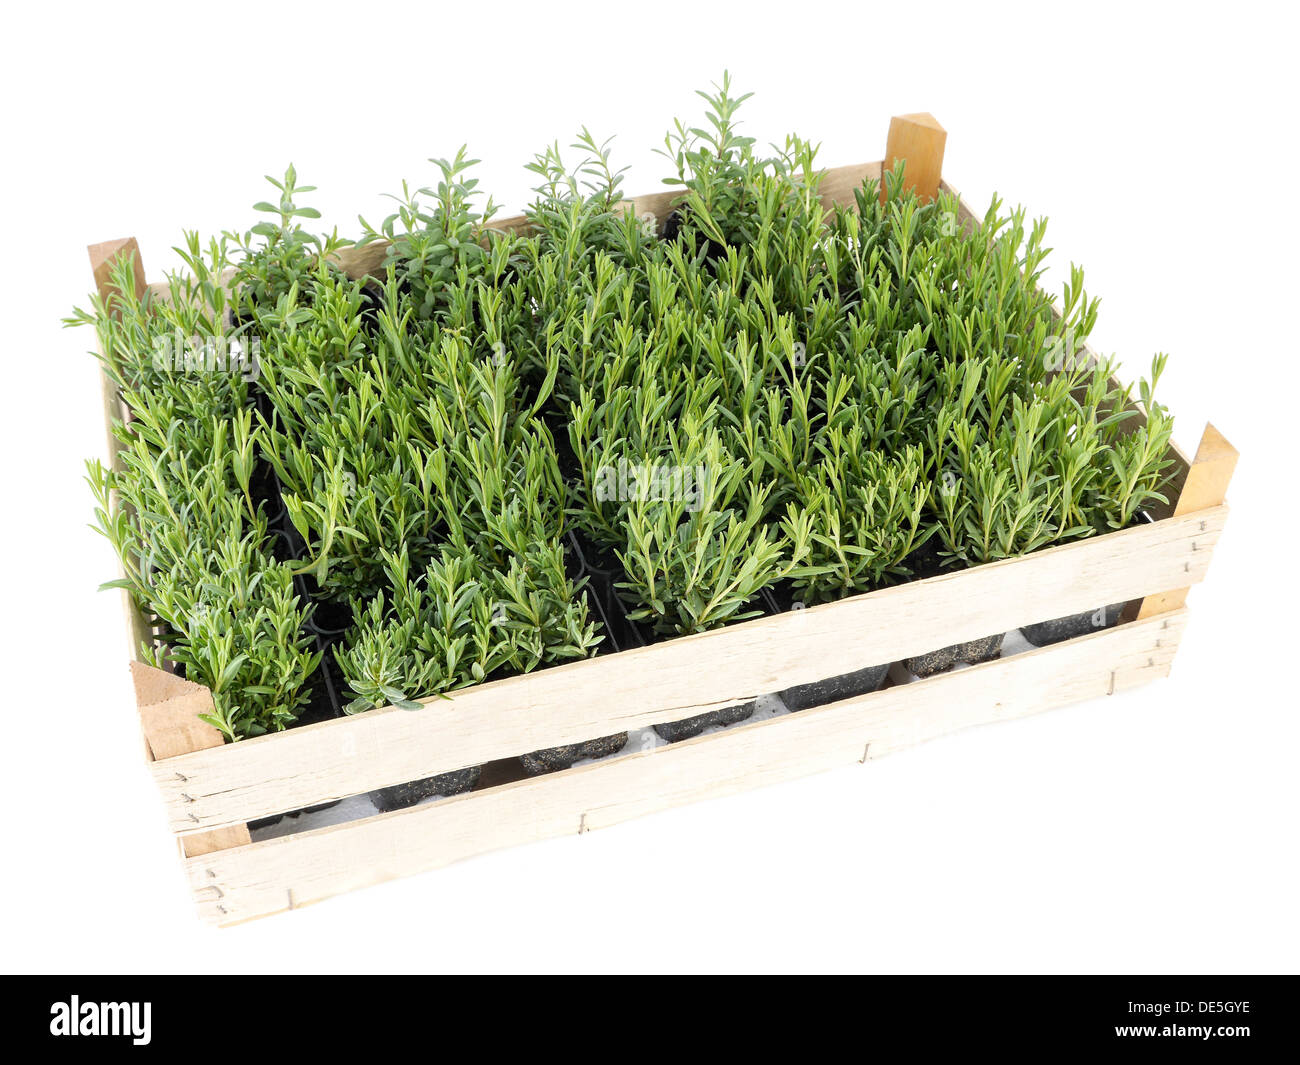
[{"left": 153, "top": 508, "right": 1226, "bottom": 832}]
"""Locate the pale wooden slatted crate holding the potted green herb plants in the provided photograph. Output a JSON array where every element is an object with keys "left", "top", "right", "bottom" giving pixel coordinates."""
[{"left": 91, "top": 116, "right": 1236, "bottom": 925}]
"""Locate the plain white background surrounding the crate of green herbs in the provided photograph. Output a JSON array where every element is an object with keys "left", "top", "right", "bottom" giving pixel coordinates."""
[{"left": 0, "top": 3, "right": 1300, "bottom": 971}]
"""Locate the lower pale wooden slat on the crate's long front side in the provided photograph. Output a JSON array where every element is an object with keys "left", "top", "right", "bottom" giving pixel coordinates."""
[{"left": 186, "top": 611, "right": 1186, "bottom": 925}]
